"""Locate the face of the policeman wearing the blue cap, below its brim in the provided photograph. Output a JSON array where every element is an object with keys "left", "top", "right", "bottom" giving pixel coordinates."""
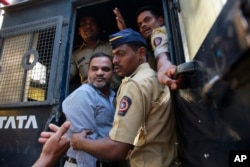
[{"left": 112, "top": 44, "right": 143, "bottom": 77}]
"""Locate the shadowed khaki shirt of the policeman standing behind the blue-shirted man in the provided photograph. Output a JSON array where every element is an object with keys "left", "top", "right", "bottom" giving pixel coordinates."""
[{"left": 70, "top": 41, "right": 121, "bottom": 90}]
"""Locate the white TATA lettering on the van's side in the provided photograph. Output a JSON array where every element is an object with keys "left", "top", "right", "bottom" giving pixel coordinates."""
[{"left": 0, "top": 115, "right": 38, "bottom": 129}]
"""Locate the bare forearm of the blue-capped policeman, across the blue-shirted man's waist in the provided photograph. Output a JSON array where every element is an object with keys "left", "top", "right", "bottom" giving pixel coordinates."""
[{"left": 72, "top": 131, "right": 133, "bottom": 161}]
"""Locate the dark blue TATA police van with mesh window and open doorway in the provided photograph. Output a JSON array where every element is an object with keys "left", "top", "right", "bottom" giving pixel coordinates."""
[{"left": 0, "top": 0, "right": 250, "bottom": 167}]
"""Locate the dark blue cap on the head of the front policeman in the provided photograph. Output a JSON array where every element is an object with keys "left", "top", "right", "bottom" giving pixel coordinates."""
[{"left": 109, "top": 28, "right": 147, "bottom": 49}]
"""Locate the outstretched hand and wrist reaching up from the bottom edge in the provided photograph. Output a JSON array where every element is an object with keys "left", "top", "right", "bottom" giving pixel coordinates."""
[{"left": 33, "top": 121, "right": 70, "bottom": 167}]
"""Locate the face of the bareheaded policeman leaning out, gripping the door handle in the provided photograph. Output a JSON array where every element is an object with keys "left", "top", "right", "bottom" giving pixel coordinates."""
[{"left": 137, "top": 11, "right": 164, "bottom": 39}]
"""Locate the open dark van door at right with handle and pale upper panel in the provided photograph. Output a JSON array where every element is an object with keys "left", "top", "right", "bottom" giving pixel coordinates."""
[{"left": 165, "top": 0, "right": 250, "bottom": 167}]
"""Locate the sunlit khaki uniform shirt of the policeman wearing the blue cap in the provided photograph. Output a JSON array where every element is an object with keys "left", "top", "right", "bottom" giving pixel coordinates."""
[{"left": 109, "top": 63, "right": 177, "bottom": 167}]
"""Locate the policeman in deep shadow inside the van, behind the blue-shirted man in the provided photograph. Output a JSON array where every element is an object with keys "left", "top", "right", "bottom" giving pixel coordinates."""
[{"left": 70, "top": 15, "right": 121, "bottom": 91}]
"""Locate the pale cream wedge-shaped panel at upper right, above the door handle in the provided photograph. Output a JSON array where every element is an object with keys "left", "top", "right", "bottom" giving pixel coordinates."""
[{"left": 180, "top": 0, "right": 227, "bottom": 59}]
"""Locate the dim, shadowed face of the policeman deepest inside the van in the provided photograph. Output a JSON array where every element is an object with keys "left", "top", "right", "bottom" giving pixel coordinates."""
[{"left": 79, "top": 16, "right": 99, "bottom": 40}]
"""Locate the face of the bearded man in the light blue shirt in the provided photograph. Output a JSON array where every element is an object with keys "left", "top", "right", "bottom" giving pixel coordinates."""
[{"left": 88, "top": 57, "right": 113, "bottom": 89}]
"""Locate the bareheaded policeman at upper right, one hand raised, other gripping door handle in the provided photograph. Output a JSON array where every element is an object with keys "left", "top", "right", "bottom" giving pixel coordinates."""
[{"left": 113, "top": 6, "right": 182, "bottom": 90}]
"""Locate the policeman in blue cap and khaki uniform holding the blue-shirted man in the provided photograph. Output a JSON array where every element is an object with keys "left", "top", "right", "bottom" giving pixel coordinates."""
[{"left": 72, "top": 29, "right": 177, "bottom": 167}]
